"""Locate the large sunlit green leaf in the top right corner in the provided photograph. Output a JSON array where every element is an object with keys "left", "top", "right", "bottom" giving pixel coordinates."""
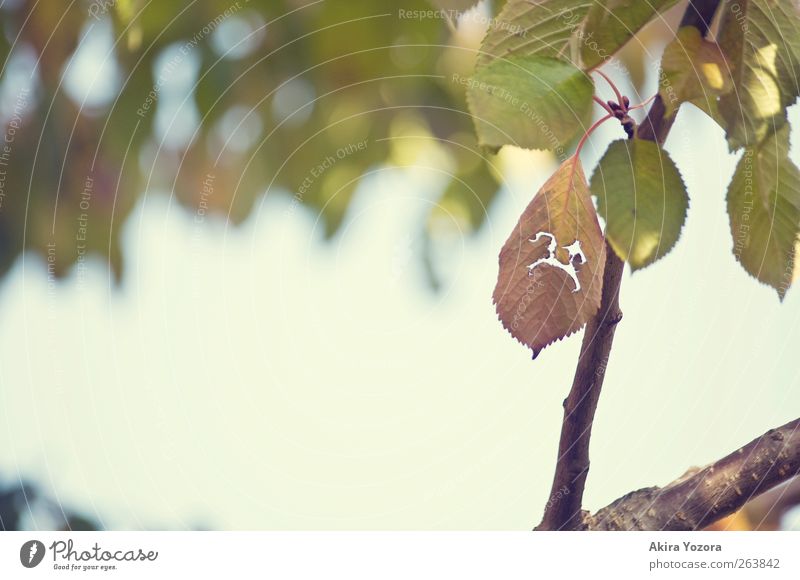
[{"left": 719, "top": 0, "right": 800, "bottom": 150}]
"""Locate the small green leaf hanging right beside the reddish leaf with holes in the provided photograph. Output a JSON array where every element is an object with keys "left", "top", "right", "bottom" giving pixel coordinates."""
[{"left": 591, "top": 139, "right": 689, "bottom": 270}]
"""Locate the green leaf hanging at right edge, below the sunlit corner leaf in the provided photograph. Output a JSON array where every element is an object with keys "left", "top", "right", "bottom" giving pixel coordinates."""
[{"left": 728, "top": 125, "right": 800, "bottom": 300}]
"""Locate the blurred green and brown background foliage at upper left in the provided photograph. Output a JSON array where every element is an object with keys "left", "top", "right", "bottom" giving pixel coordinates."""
[{"left": 0, "top": 0, "right": 660, "bottom": 280}]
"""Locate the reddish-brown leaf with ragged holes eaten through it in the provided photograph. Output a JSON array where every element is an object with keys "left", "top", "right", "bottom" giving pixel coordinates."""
[{"left": 492, "top": 157, "right": 606, "bottom": 356}]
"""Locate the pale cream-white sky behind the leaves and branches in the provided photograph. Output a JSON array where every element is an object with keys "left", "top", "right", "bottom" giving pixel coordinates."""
[{"left": 0, "top": 101, "right": 800, "bottom": 528}]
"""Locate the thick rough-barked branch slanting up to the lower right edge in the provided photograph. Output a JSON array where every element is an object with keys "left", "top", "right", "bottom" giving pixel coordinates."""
[{"left": 583, "top": 419, "right": 800, "bottom": 531}]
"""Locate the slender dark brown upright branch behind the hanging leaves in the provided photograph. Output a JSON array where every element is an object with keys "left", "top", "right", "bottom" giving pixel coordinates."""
[{"left": 536, "top": 0, "right": 720, "bottom": 530}]
